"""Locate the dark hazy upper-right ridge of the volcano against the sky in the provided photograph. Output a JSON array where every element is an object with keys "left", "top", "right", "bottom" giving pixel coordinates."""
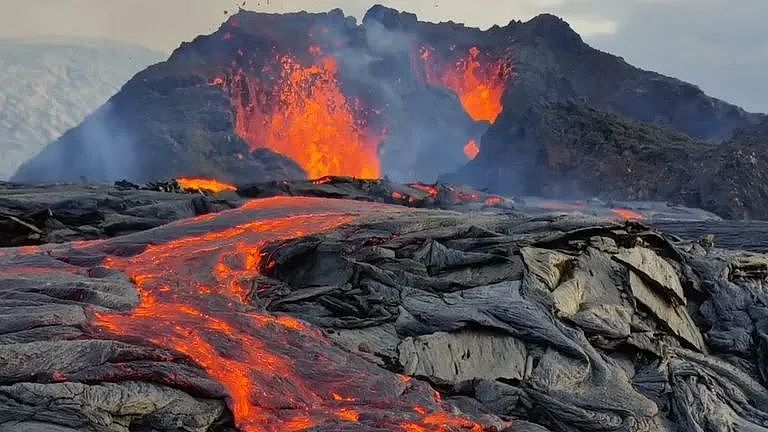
[{"left": 366, "top": 6, "right": 765, "bottom": 141}]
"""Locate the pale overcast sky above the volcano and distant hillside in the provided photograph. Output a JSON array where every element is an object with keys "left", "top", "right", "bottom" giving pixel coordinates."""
[{"left": 0, "top": 0, "right": 768, "bottom": 112}]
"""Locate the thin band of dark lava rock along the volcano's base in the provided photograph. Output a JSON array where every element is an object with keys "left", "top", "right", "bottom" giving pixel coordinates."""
[{"left": 6, "top": 177, "right": 768, "bottom": 256}]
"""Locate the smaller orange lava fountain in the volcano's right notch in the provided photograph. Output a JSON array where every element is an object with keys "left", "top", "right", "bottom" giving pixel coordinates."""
[{"left": 421, "top": 47, "right": 510, "bottom": 123}]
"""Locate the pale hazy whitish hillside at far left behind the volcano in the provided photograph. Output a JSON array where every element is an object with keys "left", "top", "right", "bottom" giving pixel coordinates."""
[{"left": 0, "top": 39, "right": 163, "bottom": 179}]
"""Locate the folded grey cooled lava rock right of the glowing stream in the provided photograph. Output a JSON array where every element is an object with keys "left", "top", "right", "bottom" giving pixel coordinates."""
[{"left": 266, "top": 208, "right": 768, "bottom": 431}]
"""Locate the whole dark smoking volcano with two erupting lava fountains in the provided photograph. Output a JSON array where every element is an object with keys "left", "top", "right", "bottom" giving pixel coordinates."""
[{"left": 14, "top": 6, "right": 768, "bottom": 218}]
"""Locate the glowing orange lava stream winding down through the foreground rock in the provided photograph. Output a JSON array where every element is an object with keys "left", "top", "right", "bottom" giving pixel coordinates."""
[{"left": 92, "top": 197, "right": 483, "bottom": 432}]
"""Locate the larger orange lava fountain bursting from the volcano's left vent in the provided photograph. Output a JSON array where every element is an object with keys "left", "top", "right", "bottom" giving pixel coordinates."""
[{"left": 224, "top": 47, "right": 383, "bottom": 178}]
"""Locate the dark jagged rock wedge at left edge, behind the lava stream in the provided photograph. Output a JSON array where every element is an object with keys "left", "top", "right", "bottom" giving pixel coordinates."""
[{"left": 0, "top": 183, "right": 241, "bottom": 246}]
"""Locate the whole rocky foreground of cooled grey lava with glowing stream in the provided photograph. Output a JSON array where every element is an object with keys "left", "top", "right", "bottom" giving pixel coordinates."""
[{"left": 0, "top": 183, "right": 768, "bottom": 432}]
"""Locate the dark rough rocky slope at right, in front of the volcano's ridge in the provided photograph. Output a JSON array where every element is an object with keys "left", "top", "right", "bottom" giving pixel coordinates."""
[{"left": 440, "top": 101, "right": 768, "bottom": 219}]
